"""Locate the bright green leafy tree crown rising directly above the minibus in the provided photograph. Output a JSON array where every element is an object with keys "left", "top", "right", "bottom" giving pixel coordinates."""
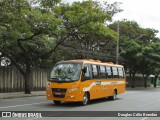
[{"left": 55, "top": 1, "right": 117, "bottom": 58}]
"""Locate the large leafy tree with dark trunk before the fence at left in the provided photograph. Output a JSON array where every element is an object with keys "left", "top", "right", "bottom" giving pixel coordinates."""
[{"left": 0, "top": 0, "right": 63, "bottom": 94}]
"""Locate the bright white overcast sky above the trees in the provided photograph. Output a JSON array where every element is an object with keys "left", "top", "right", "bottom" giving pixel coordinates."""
[{"left": 62, "top": 0, "right": 160, "bottom": 37}]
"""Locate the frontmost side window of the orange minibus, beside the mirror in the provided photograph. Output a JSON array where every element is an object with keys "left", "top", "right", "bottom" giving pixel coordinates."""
[{"left": 82, "top": 64, "right": 91, "bottom": 80}]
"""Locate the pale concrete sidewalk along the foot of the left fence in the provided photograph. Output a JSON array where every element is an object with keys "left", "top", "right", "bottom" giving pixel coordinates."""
[{"left": 0, "top": 91, "right": 46, "bottom": 99}]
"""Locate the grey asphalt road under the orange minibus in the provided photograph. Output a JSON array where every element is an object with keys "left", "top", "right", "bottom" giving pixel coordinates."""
[{"left": 0, "top": 88, "right": 160, "bottom": 120}]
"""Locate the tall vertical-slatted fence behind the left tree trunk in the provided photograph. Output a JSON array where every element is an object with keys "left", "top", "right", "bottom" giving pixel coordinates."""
[{"left": 0, "top": 67, "right": 49, "bottom": 93}]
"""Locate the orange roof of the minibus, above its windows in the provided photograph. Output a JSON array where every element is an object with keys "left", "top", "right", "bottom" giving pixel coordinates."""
[{"left": 59, "top": 59, "right": 123, "bottom": 67}]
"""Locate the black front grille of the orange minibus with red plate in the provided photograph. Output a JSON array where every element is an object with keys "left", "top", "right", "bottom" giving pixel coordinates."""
[{"left": 52, "top": 88, "right": 67, "bottom": 98}]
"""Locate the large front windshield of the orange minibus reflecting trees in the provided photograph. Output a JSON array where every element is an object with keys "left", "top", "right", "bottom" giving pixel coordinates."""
[{"left": 49, "top": 63, "right": 82, "bottom": 83}]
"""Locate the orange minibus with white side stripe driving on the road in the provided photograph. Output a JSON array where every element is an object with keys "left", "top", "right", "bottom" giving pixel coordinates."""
[{"left": 46, "top": 59, "right": 126, "bottom": 105}]
